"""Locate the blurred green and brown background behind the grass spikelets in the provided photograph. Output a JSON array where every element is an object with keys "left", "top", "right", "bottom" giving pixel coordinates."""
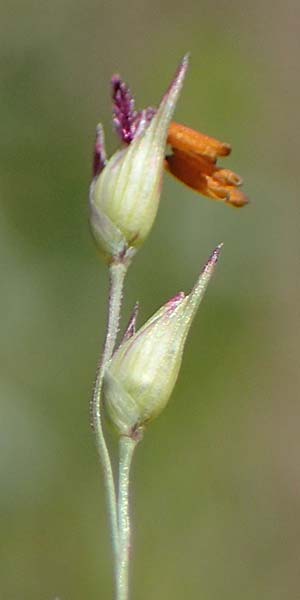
[{"left": 0, "top": 0, "right": 300, "bottom": 600}]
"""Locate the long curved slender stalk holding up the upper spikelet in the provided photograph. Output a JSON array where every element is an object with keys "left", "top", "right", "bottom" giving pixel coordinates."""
[{"left": 91, "top": 262, "right": 128, "bottom": 568}]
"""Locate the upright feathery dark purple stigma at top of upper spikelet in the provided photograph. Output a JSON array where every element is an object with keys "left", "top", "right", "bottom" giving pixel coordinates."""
[{"left": 111, "top": 75, "right": 137, "bottom": 144}]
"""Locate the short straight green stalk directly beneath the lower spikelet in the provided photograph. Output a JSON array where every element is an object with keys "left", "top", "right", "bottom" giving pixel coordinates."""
[{"left": 116, "top": 436, "right": 137, "bottom": 600}]
